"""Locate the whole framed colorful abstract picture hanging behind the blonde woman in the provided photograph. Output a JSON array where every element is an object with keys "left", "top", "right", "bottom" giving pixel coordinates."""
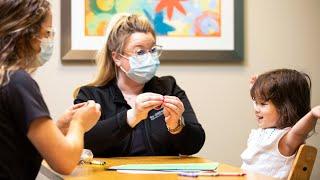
[{"left": 61, "top": 0, "right": 244, "bottom": 62}]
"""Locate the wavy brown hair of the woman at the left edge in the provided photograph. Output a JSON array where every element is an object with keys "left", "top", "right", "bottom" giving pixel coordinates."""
[{"left": 0, "top": 0, "right": 50, "bottom": 87}]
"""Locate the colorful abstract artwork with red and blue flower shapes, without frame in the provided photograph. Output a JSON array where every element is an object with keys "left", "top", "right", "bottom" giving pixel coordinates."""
[{"left": 84, "top": 0, "right": 221, "bottom": 37}]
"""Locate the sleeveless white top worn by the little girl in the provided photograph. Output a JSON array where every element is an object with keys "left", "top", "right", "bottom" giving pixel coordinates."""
[{"left": 241, "top": 127, "right": 295, "bottom": 179}]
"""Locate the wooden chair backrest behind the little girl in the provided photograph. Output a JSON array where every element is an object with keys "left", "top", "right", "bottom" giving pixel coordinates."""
[{"left": 288, "top": 144, "right": 317, "bottom": 180}]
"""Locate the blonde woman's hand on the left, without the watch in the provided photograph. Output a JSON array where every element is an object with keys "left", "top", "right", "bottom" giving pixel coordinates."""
[{"left": 127, "top": 92, "right": 163, "bottom": 127}]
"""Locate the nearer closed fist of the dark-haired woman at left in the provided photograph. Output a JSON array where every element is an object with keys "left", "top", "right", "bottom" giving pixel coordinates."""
[{"left": 72, "top": 100, "right": 101, "bottom": 132}]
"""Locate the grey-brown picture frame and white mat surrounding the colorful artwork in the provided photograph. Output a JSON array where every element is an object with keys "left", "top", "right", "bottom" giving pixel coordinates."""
[{"left": 61, "top": 0, "right": 244, "bottom": 62}]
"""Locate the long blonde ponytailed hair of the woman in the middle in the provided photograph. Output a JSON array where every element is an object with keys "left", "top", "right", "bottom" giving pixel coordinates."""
[{"left": 73, "top": 13, "right": 156, "bottom": 98}]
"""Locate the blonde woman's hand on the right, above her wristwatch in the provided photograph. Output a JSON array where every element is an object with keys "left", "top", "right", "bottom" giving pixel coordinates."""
[{"left": 163, "top": 96, "right": 184, "bottom": 129}]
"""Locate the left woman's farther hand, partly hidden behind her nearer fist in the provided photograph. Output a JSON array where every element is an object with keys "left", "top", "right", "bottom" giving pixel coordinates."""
[{"left": 56, "top": 102, "right": 86, "bottom": 135}]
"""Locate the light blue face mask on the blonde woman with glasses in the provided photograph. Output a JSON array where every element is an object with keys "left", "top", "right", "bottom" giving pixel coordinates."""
[{"left": 120, "top": 53, "right": 160, "bottom": 84}]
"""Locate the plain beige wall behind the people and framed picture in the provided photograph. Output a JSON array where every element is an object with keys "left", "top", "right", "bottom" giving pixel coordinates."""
[{"left": 35, "top": 0, "right": 320, "bottom": 179}]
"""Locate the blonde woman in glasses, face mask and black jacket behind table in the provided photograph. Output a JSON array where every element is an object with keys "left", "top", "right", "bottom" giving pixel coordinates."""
[{"left": 74, "top": 14, "right": 205, "bottom": 157}]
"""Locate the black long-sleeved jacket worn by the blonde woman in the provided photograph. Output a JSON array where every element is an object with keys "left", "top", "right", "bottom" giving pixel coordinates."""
[{"left": 74, "top": 76, "right": 205, "bottom": 157}]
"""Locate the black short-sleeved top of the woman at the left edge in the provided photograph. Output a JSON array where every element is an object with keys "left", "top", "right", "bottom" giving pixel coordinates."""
[{"left": 0, "top": 70, "right": 50, "bottom": 179}]
